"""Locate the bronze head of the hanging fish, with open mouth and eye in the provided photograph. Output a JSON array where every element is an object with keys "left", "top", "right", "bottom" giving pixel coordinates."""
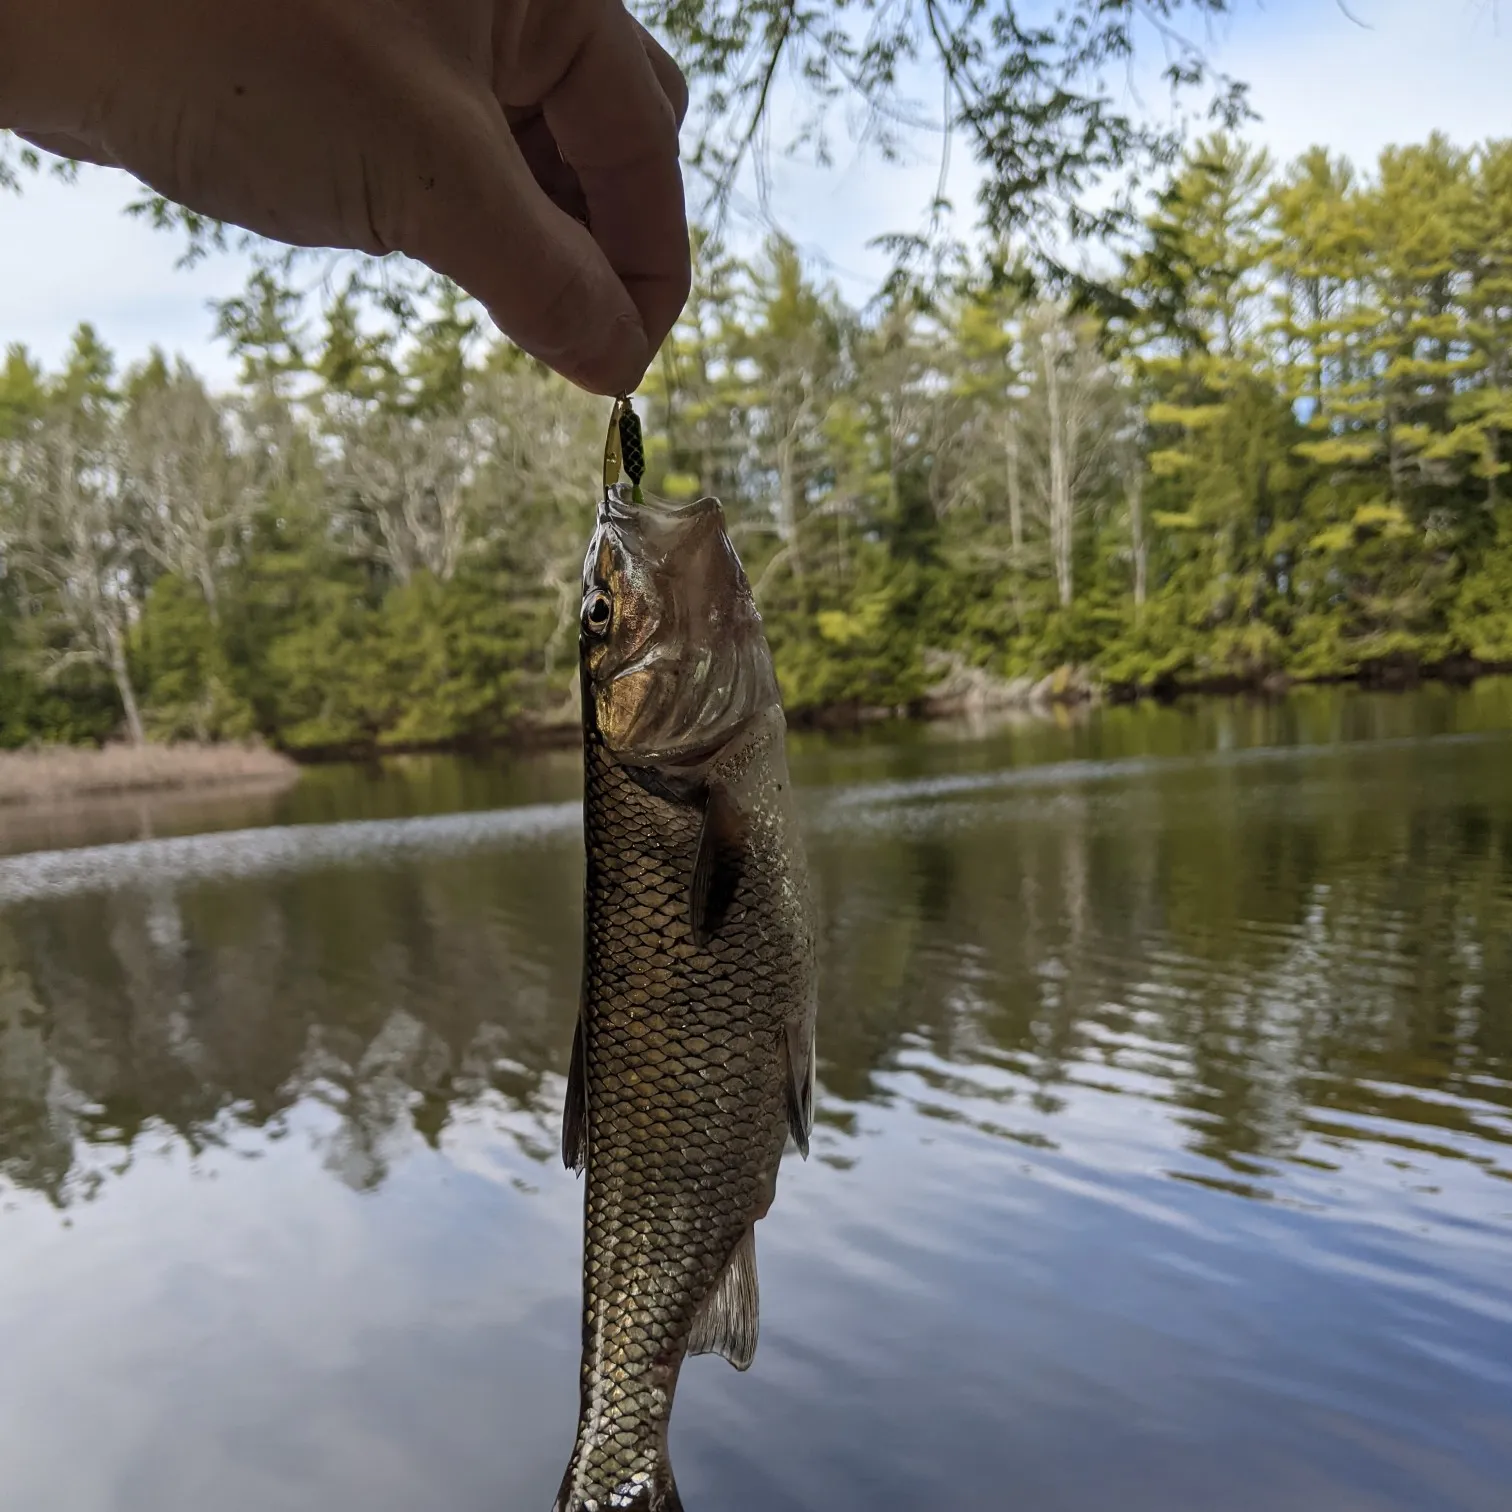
[{"left": 579, "top": 488, "right": 780, "bottom": 765}]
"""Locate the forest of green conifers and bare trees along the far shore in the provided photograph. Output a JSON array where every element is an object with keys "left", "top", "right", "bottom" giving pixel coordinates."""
[{"left": 0, "top": 133, "right": 1512, "bottom": 754}]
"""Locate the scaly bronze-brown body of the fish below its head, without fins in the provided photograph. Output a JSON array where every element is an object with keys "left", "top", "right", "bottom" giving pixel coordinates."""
[{"left": 571, "top": 734, "right": 788, "bottom": 1489}]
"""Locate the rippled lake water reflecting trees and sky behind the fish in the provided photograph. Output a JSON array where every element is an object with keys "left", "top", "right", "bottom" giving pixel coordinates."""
[{"left": 0, "top": 685, "right": 1512, "bottom": 1512}]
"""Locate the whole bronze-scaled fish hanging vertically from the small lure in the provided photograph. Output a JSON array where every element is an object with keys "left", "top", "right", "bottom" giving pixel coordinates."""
[{"left": 555, "top": 484, "right": 818, "bottom": 1512}]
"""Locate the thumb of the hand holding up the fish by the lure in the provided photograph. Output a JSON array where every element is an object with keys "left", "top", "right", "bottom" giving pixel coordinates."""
[{"left": 393, "top": 89, "right": 652, "bottom": 395}]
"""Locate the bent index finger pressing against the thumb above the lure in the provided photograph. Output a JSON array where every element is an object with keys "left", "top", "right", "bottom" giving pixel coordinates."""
[{"left": 541, "top": 0, "right": 692, "bottom": 368}]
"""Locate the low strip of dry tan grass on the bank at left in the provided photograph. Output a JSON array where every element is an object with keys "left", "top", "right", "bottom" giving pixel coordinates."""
[{"left": 0, "top": 744, "right": 299, "bottom": 806}]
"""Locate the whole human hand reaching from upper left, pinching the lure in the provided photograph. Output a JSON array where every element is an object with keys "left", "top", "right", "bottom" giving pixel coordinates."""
[{"left": 0, "top": 0, "right": 689, "bottom": 395}]
